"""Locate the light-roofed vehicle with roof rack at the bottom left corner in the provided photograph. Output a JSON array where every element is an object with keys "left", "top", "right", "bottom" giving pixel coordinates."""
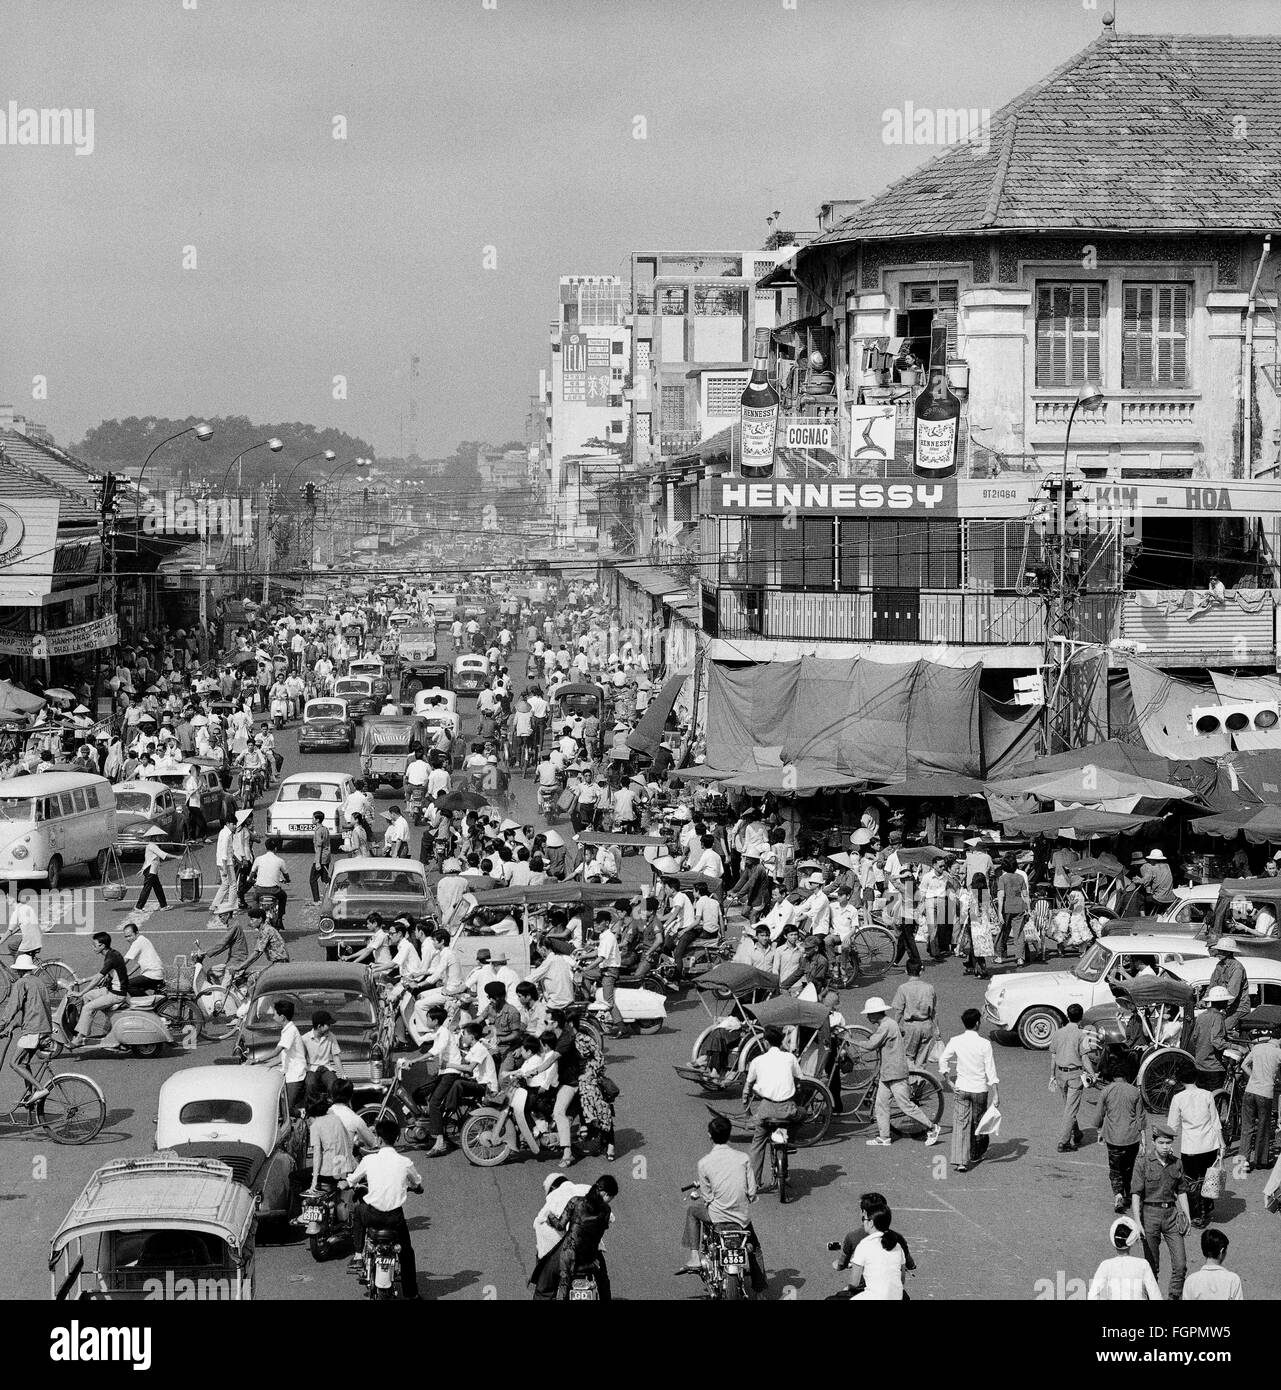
[{"left": 49, "top": 1154, "right": 258, "bottom": 1301}]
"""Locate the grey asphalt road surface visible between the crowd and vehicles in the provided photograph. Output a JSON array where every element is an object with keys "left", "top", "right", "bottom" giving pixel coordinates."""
[{"left": 0, "top": 641, "right": 1281, "bottom": 1300}]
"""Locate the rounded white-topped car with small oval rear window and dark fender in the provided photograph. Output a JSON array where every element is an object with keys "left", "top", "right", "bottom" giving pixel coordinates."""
[{"left": 156, "top": 1067, "right": 310, "bottom": 1222}]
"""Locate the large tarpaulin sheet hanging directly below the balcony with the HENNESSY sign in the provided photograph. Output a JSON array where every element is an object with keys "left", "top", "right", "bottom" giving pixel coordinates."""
[{"left": 707, "top": 656, "right": 982, "bottom": 787}]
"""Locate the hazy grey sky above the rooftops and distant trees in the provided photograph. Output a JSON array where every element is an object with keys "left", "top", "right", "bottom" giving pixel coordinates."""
[{"left": 0, "top": 0, "right": 1281, "bottom": 455}]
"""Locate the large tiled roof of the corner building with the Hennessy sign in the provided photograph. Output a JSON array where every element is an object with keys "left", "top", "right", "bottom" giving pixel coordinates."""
[{"left": 800, "top": 32, "right": 1281, "bottom": 246}]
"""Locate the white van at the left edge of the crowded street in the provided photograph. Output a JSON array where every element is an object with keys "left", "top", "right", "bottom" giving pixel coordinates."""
[{"left": 0, "top": 773, "right": 115, "bottom": 888}]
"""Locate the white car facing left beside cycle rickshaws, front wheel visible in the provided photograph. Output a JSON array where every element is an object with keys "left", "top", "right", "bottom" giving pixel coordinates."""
[{"left": 984, "top": 934, "right": 1210, "bottom": 1051}]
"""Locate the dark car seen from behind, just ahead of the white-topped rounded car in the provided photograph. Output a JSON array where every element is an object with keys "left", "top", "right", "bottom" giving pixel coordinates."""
[{"left": 232, "top": 960, "right": 395, "bottom": 1104}]
